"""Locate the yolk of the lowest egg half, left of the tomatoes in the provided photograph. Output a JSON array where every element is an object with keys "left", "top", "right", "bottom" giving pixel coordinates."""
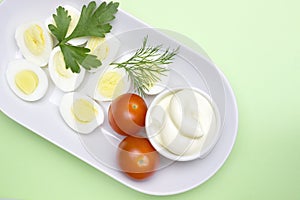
[{"left": 72, "top": 99, "right": 98, "bottom": 123}]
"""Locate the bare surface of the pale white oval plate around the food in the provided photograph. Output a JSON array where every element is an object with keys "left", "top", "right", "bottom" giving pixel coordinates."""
[{"left": 0, "top": 0, "right": 238, "bottom": 195}]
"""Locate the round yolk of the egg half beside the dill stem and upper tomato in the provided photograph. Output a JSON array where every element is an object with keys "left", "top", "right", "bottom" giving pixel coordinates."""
[{"left": 98, "top": 72, "right": 124, "bottom": 98}]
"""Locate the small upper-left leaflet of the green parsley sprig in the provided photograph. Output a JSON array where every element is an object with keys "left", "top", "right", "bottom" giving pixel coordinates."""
[{"left": 48, "top": 6, "right": 71, "bottom": 42}]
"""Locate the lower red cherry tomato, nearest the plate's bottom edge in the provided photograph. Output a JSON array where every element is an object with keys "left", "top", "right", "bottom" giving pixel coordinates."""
[{"left": 117, "top": 136, "right": 159, "bottom": 180}]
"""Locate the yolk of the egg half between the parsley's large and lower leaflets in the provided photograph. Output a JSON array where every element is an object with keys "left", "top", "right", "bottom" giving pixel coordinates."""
[{"left": 87, "top": 37, "right": 109, "bottom": 60}]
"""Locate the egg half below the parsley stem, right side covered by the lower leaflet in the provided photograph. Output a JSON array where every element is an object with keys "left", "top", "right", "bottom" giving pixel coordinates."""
[{"left": 48, "top": 47, "right": 85, "bottom": 92}]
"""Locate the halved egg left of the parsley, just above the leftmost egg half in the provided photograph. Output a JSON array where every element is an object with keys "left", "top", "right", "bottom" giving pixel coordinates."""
[{"left": 15, "top": 22, "right": 53, "bottom": 66}]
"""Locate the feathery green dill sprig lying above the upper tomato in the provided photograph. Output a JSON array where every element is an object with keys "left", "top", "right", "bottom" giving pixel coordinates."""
[{"left": 111, "top": 37, "right": 179, "bottom": 96}]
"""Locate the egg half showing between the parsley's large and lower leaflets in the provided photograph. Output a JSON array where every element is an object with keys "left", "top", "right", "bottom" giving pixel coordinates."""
[{"left": 86, "top": 33, "right": 120, "bottom": 72}]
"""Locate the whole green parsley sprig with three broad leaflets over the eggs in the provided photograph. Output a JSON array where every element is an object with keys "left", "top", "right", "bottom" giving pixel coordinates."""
[{"left": 48, "top": 1, "right": 119, "bottom": 73}]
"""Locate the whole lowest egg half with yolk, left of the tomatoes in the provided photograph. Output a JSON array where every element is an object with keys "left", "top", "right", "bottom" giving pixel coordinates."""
[{"left": 59, "top": 92, "right": 104, "bottom": 134}]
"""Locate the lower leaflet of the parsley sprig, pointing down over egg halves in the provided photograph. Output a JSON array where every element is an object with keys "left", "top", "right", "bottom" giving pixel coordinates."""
[{"left": 60, "top": 44, "right": 101, "bottom": 73}]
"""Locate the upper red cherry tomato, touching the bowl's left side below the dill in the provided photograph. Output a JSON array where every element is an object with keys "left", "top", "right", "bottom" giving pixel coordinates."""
[{"left": 108, "top": 93, "right": 148, "bottom": 136}]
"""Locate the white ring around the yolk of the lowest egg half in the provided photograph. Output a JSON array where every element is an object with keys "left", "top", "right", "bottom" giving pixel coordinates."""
[{"left": 59, "top": 92, "right": 104, "bottom": 134}]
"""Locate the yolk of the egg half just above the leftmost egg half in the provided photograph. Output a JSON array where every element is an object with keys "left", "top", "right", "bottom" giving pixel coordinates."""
[{"left": 24, "top": 25, "right": 46, "bottom": 56}]
